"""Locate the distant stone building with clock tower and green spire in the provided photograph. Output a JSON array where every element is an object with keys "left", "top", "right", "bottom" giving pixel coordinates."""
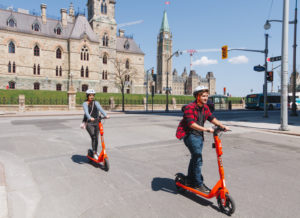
[{"left": 156, "top": 11, "right": 216, "bottom": 95}]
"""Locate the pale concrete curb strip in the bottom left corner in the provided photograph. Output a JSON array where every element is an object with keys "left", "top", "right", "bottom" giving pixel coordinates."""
[{"left": 0, "top": 162, "right": 8, "bottom": 218}]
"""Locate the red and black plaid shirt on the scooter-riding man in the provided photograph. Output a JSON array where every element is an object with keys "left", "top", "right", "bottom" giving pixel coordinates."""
[{"left": 176, "top": 101, "right": 215, "bottom": 139}]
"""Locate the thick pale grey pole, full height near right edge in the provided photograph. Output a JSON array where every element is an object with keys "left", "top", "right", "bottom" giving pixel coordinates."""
[{"left": 280, "top": 0, "right": 289, "bottom": 131}]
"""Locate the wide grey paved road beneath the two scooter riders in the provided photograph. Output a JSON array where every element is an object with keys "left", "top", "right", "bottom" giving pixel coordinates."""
[{"left": 0, "top": 112, "right": 300, "bottom": 218}]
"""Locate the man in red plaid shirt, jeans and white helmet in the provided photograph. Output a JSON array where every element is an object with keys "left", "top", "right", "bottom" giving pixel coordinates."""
[{"left": 176, "top": 86, "right": 229, "bottom": 194}]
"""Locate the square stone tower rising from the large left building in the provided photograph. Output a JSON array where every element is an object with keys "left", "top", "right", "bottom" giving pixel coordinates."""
[{"left": 87, "top": 0, "right": 118, "bottom": 92}]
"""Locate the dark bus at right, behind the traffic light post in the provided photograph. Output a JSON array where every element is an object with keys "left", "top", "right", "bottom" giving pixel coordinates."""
[{"left": 245, "top": 93, "right": 281, "bottom": 110}]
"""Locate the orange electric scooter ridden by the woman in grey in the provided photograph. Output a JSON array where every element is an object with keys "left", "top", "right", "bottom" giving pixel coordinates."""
[{"left": 87, "top": 117, "right": 109, "bottom": 171}]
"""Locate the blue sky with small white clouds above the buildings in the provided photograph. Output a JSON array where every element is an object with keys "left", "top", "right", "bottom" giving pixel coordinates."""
[{"left": 0, "top": 0, "right": 300, "bottom": 96}]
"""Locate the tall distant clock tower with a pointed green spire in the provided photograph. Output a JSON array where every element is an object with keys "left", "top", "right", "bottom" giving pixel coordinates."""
[{"left": 156, "top": 11, "right": 173, "bottom": 93}]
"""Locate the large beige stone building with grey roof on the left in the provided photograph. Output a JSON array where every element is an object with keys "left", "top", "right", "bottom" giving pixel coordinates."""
[{"left": 0, "top": 0, "right": 145, "bottom": 93}]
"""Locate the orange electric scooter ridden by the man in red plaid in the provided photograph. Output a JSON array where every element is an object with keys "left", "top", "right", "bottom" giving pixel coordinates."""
[{"left": 175, "top": 127, "right": 235, "bottom": 215}]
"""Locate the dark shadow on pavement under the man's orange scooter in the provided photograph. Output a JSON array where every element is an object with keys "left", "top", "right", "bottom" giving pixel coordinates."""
[{"left": 151, "top": 177, "right": 220, "bottom": 212}]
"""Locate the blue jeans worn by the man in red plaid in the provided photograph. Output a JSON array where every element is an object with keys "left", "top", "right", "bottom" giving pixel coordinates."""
[{"left": 184, "top": 134, "right": 203, "bottom": 186}]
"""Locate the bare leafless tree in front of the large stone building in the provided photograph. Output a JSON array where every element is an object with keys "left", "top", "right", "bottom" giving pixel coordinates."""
[{"left": 112, "top": 58, "right": 137, "bottom": 111}]
